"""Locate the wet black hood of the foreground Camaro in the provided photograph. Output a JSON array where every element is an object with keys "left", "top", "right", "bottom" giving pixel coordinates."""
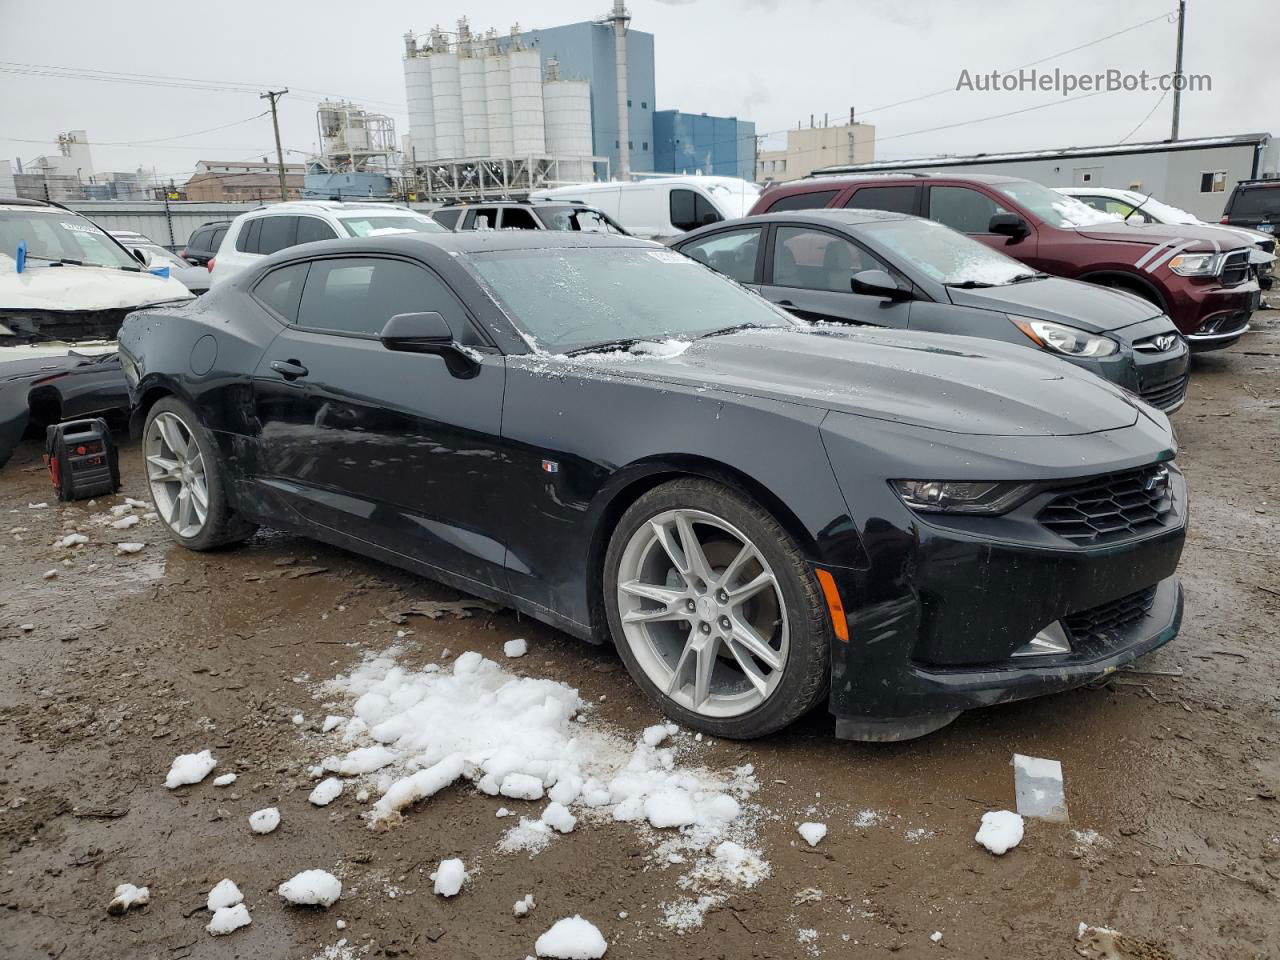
[{"left": 566, "top": 326, "right": 1138, "bottom": 436}]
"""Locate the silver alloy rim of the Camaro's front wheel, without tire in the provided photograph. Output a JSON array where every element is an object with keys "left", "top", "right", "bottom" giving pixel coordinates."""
[{"left": 617, "top": 509, "right": 790, "bottom": 718}]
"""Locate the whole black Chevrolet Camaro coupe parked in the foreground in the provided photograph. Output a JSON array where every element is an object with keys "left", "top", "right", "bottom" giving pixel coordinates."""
[{"left": 120, "top": 232, "right": 1187, "bottom": 740}]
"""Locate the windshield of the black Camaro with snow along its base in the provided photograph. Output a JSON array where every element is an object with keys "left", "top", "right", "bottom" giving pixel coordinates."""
[{"left": 465, "top": 247, "right": 795, "bottom": 353}]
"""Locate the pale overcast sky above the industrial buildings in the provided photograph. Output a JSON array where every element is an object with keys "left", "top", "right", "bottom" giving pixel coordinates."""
[{"left": 0, "top": 0, "right": 1280, "bottom": 182}]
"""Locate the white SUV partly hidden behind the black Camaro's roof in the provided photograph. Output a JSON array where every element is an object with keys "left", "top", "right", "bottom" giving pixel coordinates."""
[{"left": 209, "top": 200, "right": 448, "bottom": 287}]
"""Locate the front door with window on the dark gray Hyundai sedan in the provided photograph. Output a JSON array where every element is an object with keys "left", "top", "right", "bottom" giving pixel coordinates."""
[{"left": 760, "top": 224, "right": 911, "bottom": 328}]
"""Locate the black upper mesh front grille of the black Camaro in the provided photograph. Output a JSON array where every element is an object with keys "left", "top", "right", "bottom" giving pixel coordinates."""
[{"left": 1038, "top": 463, "right": 1174, "bottom": 547}]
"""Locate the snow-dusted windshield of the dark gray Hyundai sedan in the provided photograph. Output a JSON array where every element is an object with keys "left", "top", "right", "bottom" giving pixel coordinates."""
[{"left": 861, "top": 218, "right": 1036, "bottom": 287}]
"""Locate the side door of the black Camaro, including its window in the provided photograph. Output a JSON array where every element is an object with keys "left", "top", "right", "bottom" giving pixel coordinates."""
[{"left": 253, "top": 256, "right": 506, "bottom": 589}]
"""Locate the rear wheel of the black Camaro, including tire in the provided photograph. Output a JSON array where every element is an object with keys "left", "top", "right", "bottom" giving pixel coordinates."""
[{"left": 142, "top": 397, "right": 257, "bottom": 550}]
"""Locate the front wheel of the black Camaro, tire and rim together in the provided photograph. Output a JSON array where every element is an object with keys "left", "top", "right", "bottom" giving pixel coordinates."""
[{"left": 604, "top": 477, "right": 831, "bottom": 740}]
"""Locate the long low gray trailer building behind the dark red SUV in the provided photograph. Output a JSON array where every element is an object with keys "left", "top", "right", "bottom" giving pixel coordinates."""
[{"left": 814, "top": 133, "right": 1280, "bottom": 221}]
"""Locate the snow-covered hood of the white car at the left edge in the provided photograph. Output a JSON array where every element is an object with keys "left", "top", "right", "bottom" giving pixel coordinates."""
[{"left": 0, "top": 255, "right": 191, "bottom": 310}]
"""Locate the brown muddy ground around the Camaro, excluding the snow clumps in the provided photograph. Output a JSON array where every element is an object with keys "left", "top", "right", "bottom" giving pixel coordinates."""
[{"left": 0, "top": 311, "right": 1280, "bottom": 960}]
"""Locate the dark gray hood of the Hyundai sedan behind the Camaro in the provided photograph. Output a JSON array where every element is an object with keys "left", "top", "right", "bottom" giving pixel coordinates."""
[{"left": 947, "top": 276, "right": 1160, "bottom": 333}]
